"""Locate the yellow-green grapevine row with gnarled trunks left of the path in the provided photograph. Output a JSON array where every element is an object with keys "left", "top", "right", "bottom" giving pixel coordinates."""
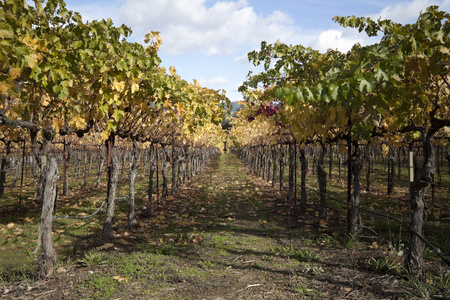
[{"left": 0, "top": 0, "right": 230, "bottom": 276}]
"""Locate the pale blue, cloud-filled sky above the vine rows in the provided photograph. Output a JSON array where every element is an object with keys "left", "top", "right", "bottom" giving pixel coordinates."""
[{"left": 62, "top": 0, "right": 450, "bottom": 101}]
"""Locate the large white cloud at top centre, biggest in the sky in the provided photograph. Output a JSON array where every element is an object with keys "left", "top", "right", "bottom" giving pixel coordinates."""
[{"left": 121, "top": 0, "right": 296, "bottom": 56}]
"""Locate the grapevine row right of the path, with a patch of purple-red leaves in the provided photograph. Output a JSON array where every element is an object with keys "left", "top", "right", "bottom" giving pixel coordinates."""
[{"left": 229, "top": 6, "right": 450, "bottom": 276}]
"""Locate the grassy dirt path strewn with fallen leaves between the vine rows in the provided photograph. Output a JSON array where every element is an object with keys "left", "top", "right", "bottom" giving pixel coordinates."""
[{"left": 0, "top": 154, "right": 418, "bottom": 299}]
